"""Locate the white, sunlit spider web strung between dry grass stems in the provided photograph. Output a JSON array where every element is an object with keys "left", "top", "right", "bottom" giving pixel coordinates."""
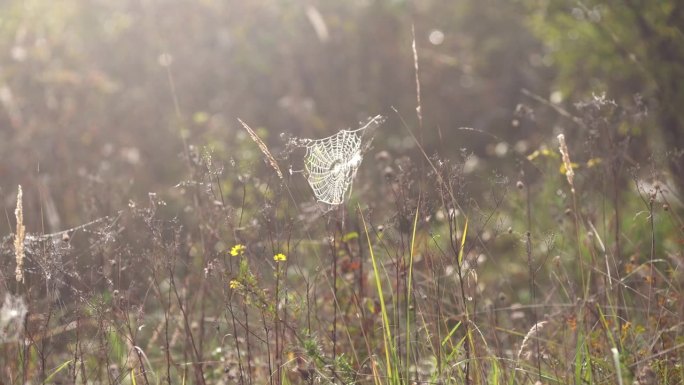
[{"left": 301, "top": 115, "right": 384, "bottom": 205}]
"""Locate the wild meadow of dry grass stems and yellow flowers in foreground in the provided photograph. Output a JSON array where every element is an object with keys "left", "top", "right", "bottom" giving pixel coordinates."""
[{"left": 0, "top": 87, "right": 684, "bottom": 385}]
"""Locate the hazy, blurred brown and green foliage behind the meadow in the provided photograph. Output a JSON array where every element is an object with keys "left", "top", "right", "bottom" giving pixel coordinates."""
[{"left": 0, "top": 0, "right": 684, "bottom": 228}]
